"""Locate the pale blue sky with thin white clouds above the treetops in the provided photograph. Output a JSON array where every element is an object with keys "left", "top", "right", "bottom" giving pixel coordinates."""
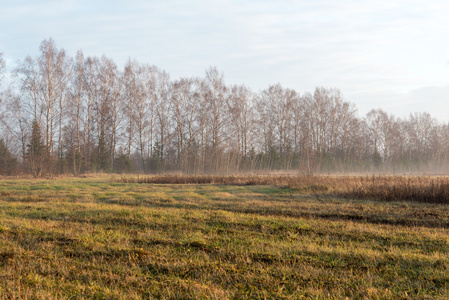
[{"left": 0, "top": 0, "right": 449, "bottom": 122}]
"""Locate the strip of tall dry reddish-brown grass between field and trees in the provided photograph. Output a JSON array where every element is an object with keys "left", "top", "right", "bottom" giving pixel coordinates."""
[{"left": 118, "top": 175, "right": 449, "bottom": 204}]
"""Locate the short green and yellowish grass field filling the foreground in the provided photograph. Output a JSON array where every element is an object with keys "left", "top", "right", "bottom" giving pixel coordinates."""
[{"left": 0, "top": 177, "right": 449, "bottom": 299}]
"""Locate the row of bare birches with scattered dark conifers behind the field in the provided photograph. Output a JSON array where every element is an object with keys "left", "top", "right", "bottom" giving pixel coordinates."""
[{"left": 0, "top": 39, "right": 449, "bottom": 176}]
